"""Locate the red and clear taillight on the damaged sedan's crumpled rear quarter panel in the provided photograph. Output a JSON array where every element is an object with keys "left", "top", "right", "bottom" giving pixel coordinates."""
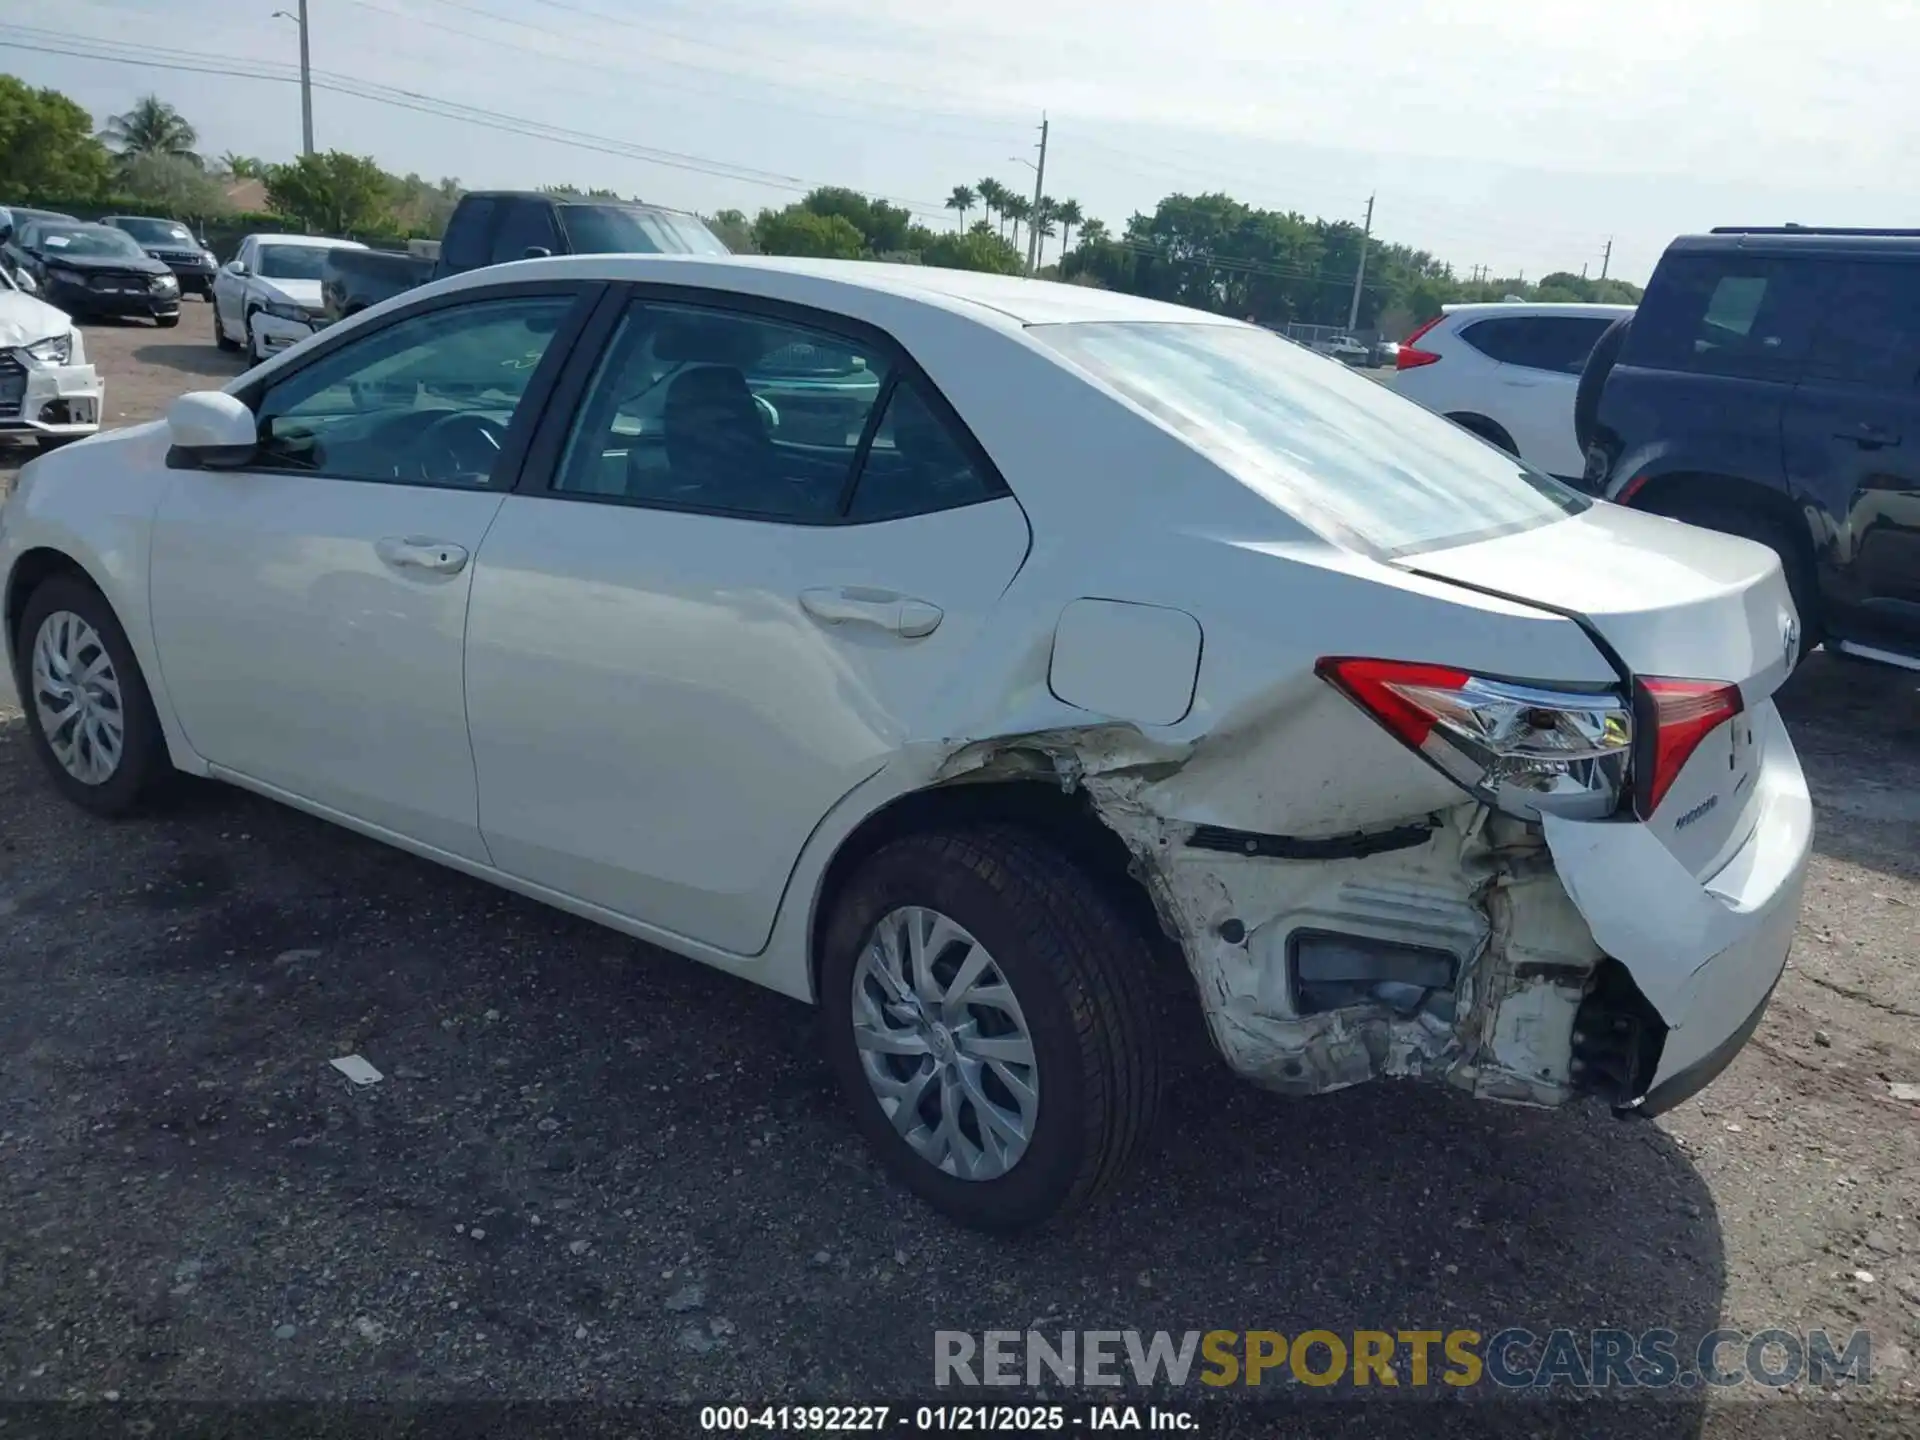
[{"left": 1315, "top": 657, "right": 1634, "bottom": 820}]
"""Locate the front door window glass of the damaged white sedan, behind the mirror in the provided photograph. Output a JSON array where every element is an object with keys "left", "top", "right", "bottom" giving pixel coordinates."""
[{"left": 255, "top": 296, "right": 574, "bottom": 488}]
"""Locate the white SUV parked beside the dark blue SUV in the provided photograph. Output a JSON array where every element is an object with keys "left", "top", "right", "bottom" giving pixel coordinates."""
[{"left": 1392, "top": 301, "right": 1634, "bottom": 480}]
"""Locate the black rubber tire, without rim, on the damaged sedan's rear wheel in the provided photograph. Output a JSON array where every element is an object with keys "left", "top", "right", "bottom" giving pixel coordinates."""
[{"left": 820, "top": 826, "right": 1162, "bottom": 1233}]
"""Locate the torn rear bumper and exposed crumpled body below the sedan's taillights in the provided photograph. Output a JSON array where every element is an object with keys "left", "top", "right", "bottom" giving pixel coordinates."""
[{"left": 1083, "top": 707, "right": 1812, "bottom": 1114}]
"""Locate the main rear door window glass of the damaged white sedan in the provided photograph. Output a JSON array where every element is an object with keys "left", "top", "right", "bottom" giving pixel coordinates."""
[{"left": 553, "top": 301, "right": 889, "bottom": 524}]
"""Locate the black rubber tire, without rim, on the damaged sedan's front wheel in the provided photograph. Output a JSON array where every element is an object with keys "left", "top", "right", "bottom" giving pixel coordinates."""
[{"left": 13, "top": 574, "right": 175, "bottom": 816}]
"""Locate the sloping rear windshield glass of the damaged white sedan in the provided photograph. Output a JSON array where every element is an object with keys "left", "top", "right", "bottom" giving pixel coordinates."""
[{"left": 1029, "top": 323, "right": 1590, "bottom": 555}]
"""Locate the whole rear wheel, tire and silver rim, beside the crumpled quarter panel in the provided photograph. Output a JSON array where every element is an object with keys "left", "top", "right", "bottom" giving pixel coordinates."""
[{"left": 820, "top": 828, "right": 1162, "bottom": 1231}]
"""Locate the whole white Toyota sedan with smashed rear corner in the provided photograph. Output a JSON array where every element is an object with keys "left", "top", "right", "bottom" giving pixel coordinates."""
[{"left": 0, "top": 255, "right": 1812, "bottom": 1229}]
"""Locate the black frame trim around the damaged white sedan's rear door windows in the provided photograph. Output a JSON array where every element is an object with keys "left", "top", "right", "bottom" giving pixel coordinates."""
[{"left": 513, "top": 280, "right": 1014, "bottom": 530}]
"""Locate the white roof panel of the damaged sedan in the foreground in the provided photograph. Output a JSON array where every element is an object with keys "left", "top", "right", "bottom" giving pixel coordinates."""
[{"left": 438, "top": 255, "right": 1242, "bottom": 334}]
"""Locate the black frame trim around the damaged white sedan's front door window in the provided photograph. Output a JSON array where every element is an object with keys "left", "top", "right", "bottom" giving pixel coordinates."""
[{"left": 167, "top": 280, "right": 609, "bottom": 495}]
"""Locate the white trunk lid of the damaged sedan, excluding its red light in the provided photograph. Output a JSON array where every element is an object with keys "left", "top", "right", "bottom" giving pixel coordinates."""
[{"left": 1400, "top": 503, "right": 1799, "bottom": 879}]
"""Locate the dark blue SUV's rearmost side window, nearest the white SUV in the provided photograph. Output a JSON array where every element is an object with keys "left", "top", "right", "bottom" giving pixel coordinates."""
[{"left": 1622, "top": 253, "right": 1820, "bottom": 378}]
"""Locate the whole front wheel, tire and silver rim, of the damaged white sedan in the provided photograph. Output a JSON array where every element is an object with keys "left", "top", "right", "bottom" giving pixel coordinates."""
[{"left": 13, "top": 576, "right": 173, "bottom": 816}]
